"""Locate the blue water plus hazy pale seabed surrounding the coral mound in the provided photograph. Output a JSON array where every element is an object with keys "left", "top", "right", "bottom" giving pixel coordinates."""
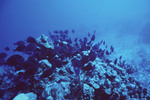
[{"left": 0, "top": 0, "right": 150, "bottom": 100}]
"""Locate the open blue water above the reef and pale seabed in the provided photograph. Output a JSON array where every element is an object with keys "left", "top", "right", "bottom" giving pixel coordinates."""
[{"left": 0, "top": 0, "right": 150, "bottom": 49}]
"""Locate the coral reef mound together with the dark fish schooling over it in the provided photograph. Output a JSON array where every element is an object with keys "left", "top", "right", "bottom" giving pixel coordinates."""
[{"left": 0, "top": 30, "right": 150, "bottom": 100}]
